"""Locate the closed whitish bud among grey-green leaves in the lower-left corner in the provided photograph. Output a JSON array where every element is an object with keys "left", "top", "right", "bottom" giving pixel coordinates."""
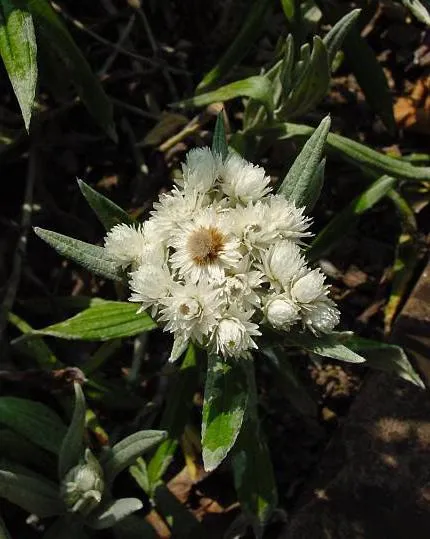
[{"left": 61, "top": 449, "right": 104, "bottom": 516}]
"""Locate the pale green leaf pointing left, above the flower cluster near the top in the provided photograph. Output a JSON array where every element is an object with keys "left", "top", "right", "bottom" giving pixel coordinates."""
[{"left": 172, "top": 75, "right": 273, "bottom": 113}]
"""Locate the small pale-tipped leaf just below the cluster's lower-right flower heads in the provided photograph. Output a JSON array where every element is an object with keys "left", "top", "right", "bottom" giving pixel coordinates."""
[{"left": 286, "top": 333, "right": 366, "bottom": 363}]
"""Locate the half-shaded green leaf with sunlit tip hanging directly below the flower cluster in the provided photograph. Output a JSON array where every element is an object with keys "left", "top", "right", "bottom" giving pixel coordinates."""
[{"left": 202, "top": 355, "right": 248, "bottom": 472}]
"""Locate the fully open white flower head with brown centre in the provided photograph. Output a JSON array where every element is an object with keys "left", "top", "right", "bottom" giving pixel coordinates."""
[{"left": 170, "top": 207, "right": 242, "bottom": 283}]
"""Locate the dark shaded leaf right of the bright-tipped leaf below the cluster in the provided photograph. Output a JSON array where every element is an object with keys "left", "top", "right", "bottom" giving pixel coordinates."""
[{"left": 232, "top": 362, "right": 278, "bottom": 538}]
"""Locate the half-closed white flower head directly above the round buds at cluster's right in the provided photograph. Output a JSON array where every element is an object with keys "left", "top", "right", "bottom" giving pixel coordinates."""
[{"left": 262, "top": 240, "right": 308, "bottom": 291}]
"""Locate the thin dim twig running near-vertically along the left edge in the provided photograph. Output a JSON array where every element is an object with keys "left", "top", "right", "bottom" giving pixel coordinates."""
[{"left": 0, "top": 144, "right": 36, "bottom": 342}]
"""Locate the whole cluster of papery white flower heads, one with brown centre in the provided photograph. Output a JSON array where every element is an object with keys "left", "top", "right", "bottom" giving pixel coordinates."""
[{"left": 105, "top": 148, "right": 339, "bottom": 360}]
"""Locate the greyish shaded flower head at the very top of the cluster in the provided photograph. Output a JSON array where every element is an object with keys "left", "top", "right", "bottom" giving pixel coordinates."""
[{"left": 177, "top": 147, "right": 221, "bottom": 193}]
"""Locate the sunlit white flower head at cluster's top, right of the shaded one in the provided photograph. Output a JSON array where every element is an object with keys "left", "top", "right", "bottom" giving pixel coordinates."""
[{"left": 219, "top": 153, "right": 271, "bottom": 204}]
